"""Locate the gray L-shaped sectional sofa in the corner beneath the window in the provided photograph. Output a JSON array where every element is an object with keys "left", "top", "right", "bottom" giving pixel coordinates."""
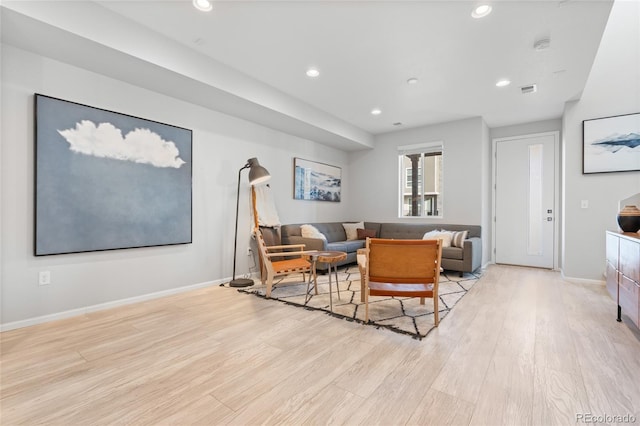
[{"left": 280, "top": 222, "right": 482, "bottom": 274}]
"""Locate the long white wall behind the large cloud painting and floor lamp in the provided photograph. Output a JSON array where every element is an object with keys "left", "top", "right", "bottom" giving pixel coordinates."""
[{"left": 0, "top": 45, "right": 350, "bottom": 328}]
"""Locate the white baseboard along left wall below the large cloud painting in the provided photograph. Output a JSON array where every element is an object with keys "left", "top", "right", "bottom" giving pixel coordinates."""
[{"left": 0, "top": 278, "right": 229, "bottom": 332}]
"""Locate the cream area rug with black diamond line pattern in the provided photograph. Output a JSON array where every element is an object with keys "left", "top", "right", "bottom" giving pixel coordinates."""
[{"left": 238, "top": 265, "right": 480, "bottom": 339}]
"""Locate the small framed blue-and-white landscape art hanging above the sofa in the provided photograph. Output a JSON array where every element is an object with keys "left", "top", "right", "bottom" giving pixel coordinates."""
[{"left": 293, "top": 158, "right": 342, "bottom": 202}]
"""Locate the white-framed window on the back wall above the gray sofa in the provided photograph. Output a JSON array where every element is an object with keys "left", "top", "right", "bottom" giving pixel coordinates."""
[{"left": 398, "top": 142, "right": 443, "bottom": 217}]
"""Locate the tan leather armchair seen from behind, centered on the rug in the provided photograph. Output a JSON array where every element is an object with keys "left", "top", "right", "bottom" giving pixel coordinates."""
[{"left": 364, "top": 238, "right": 442, "bottom": 327}]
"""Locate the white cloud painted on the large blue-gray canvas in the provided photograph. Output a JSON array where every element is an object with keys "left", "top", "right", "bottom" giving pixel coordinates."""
[{"left": 58, "top": 120, "right": 185, "bottom": 169}]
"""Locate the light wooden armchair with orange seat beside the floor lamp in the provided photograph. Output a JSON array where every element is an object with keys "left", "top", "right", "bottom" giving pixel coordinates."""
[{"left": 255, "top": 228, "right": 316, "bottom": 297}]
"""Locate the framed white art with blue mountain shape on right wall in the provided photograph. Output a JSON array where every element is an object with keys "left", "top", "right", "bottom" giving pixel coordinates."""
[{"left": 582, "top": 113, "right": 640, "bottom": 174}]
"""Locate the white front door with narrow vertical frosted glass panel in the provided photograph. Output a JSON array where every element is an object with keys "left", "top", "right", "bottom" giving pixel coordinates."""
[{"left": 494, "top": 133, "right": 558, "bottom": 268}]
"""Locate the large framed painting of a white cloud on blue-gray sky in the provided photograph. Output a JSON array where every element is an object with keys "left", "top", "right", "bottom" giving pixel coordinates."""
[{"left": 34, "top": 94, "right": 192, "bottom": 256}]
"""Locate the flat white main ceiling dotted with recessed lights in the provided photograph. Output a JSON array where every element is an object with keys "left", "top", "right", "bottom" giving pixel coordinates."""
[{"left": 100, "top": 0, "right": 611, "bottom": 134}]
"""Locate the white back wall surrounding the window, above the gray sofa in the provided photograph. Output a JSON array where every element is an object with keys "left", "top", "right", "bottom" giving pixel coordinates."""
[{"left": 348, "top": 117, "right": 491, "bottom": 258}]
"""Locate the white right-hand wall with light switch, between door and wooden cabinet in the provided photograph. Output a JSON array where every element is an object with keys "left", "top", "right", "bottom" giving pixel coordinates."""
[{"left": 563, "top": 1, "right": 640, "bottom": 280}]
